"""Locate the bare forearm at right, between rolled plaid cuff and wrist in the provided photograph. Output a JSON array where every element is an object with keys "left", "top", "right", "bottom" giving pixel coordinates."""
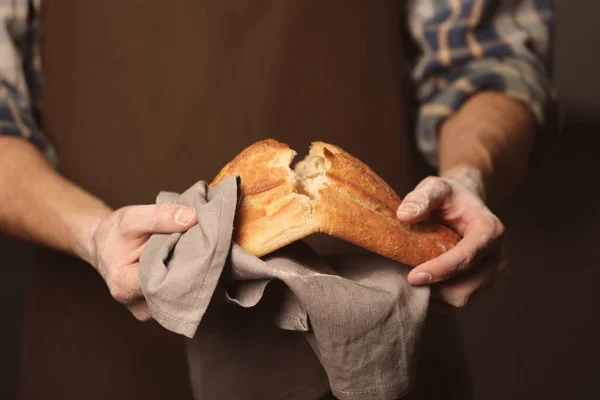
[{"left": 439, "top": 92, "right": 536, "bottom": 206}]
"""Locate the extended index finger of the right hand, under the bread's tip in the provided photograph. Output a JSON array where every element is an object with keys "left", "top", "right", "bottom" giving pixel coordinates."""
[{"left": 408, "top": 222, "right": 500, "bottom": 285}]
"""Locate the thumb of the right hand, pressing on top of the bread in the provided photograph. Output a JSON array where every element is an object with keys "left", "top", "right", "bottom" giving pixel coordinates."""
[{"left": 396, "top": 177, "right": 451, "bottom": 223}]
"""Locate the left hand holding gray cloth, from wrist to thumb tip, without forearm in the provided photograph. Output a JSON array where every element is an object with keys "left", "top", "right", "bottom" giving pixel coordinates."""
[{"left": 83, "top": 204, "right": 197, "bottom": 321}]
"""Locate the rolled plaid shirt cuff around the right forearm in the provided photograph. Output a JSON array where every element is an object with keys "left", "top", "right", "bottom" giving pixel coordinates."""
[{"left": 416, "top": 58, "right": 559, "bottom": 167}]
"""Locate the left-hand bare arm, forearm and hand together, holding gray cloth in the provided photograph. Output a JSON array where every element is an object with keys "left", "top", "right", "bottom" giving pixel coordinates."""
[{"left": 0, "top": 135, "right": 197, "bottom": 320}]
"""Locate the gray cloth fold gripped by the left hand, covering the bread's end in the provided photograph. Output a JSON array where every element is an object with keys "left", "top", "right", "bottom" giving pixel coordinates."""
[{"left": 140, "top": 177, "right": 239, "bottom": 338}]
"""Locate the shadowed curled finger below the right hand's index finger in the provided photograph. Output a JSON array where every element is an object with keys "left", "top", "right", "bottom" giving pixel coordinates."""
[{"left": 435, "top": 253, "right": 505, "bottom": 307}]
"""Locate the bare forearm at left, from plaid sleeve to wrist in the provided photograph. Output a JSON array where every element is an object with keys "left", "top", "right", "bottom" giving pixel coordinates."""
[{"left": 0, "top": 137, "right": 111, "bottom": 261}]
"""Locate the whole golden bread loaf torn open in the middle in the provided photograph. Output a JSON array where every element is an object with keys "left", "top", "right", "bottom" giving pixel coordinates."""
[{"left": 211, "top": 139, "right": 460, "bottom": 266}]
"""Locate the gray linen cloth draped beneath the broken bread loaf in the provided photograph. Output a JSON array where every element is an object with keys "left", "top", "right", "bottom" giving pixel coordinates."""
[{"left": 140, "top": 177, "right": 429, "bottom": 400}]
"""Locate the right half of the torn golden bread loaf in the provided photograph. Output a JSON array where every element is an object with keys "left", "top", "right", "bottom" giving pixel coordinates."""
[{"left": 311, "top": 142, "right": 460, "bottom": 266}]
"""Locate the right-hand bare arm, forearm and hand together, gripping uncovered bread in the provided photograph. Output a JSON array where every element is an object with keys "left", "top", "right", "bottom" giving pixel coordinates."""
[{"left": 398, "top": 91, "right": 536, "bottom": 307}]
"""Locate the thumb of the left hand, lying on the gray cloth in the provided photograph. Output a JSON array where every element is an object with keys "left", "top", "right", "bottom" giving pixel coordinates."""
[{"left": 118, "top": 204, "right": 198, "bottom": 236}]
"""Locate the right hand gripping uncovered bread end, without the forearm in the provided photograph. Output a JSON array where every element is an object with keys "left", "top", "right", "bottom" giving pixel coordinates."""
[{"left": 398, "top": 168, "right": 506, "bottom": 307}]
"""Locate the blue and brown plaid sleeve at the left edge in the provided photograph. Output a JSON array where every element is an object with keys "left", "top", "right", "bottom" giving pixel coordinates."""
[{"left": 0, "top": 0, "right": 56, "bottom": 162}]
